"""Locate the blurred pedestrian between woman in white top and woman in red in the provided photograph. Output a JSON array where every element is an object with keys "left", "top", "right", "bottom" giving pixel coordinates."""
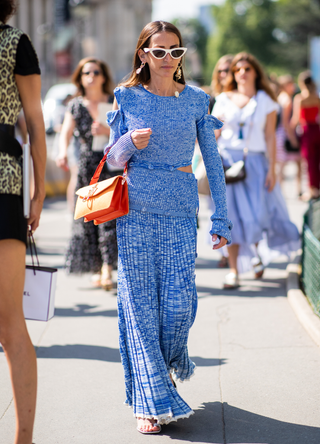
[{"left": 276, "top": 74, "right": 302, "bottom": 196}]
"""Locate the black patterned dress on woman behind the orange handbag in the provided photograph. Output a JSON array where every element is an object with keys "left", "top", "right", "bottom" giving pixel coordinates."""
[{"left": 66, "top": 97, "right": 118, "bottom": 273}]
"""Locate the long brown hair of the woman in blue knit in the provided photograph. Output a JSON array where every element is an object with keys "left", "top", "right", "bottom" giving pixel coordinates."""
[{"left": 121, "top": 21, "right": 186, "bottom": 88}]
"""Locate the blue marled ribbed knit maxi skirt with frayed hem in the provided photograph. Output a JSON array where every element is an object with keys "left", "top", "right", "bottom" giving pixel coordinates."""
[{"left": 117, "top": 210, "right": 197, "bottom": 424}]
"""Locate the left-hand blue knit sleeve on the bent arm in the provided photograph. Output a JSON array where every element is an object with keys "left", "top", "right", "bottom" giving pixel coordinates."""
[{"left": 104, "top": 88, "right": 138, "bottom": 168}]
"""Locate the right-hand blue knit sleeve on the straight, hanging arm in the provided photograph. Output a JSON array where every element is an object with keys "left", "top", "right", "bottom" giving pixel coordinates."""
[{"left": 197, "top": 97, "right": 233, "bottom": 244}]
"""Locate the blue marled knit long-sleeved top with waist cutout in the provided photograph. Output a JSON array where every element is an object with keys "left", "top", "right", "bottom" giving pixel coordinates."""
[{"left": 106, "top": 85, "right": 232, "bottom": 243}]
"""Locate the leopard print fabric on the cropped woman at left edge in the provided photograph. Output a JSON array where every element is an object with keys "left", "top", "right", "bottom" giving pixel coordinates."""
[{"left": 0, "top": 22, "right": 23, "bottom": 196}]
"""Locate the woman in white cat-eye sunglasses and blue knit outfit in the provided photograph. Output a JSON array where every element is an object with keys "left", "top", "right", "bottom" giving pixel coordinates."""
[{"left": 107, "top": 22, "right": 232, "bottom": 433}]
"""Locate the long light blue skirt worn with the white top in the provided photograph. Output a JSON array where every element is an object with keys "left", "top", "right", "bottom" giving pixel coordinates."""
[{"left": 222, "top": 149, "right": 300, "bottom": 273}]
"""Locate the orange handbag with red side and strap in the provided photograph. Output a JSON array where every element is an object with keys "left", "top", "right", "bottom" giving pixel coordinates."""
[{"left": 74, "top": 153, "right": 129, "bottom": 225}]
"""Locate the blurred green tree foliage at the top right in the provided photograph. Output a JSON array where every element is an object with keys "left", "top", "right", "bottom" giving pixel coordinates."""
[{"left": 205, "top": 0, "right": 320, "bottom": 83}]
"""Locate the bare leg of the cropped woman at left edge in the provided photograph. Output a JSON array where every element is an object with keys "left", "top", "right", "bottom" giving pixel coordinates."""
[{"left": 0, "top": 239, "right": 37, "bottom": 444}]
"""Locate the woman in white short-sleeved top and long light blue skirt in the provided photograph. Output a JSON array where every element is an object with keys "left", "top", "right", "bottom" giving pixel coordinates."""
[{"left": 212, "top": 52, "right": 299, "bottom": 288}]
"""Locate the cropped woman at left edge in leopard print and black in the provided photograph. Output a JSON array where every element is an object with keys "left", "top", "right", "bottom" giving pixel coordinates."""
[{"left": 0, "top": 0, "right": 46, "bottom": 444}]
